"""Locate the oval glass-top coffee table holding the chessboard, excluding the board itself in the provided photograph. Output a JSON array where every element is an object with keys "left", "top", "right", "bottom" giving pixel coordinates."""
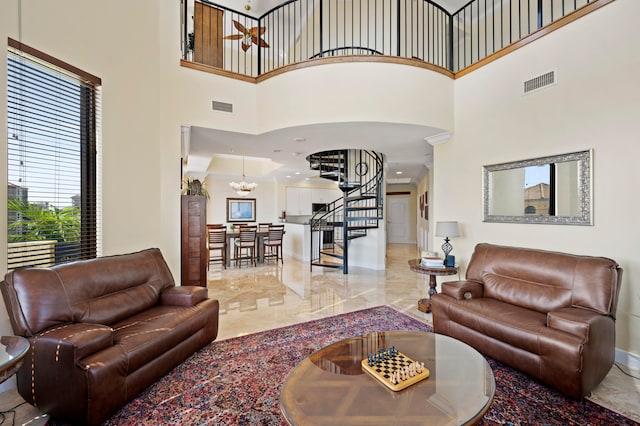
[{"left": 280, "top": 331, "right": 495, "bottom": 425}]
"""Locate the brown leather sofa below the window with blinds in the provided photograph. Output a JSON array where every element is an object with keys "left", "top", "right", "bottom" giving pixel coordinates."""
[{"left": 0, "top": 249, "right": 219, "bottom": 425}]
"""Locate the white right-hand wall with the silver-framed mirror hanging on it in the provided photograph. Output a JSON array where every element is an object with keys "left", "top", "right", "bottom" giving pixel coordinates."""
[{"left": 433, "top": 0, "right": 640, "bottom": 360}]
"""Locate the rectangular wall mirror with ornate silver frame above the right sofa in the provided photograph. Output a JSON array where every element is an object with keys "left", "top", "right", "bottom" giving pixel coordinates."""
[{"left": 483, "top": 150, "right": 592, "bottom": 225}]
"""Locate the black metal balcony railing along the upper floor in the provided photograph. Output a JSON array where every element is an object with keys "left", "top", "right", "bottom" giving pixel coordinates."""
[{"left": 181, "top": 0, "right": 604, "bottom": 77}]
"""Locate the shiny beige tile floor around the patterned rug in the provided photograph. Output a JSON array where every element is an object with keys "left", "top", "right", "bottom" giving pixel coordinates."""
[{"left": 0, "top": 244, "right": 640, "bottom": 424}]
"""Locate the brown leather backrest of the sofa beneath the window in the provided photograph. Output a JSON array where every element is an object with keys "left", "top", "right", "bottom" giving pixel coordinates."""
[{"left": 2, "top": 249, "right": 175, "bottom": 337}]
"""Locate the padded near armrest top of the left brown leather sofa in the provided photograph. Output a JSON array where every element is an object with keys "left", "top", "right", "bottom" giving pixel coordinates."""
[{"left": 30, "top": 323, "right": 113, "bottom": 365}]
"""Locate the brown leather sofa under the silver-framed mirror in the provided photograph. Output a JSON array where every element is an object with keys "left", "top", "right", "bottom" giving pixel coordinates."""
[{"left": 431, "top": 243, "right": 622, "bottom": 400}]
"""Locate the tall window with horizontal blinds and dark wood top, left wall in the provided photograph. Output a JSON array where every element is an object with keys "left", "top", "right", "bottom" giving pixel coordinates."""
[{"left": 7, "top": 39, "right": 101, "bottom": 270}]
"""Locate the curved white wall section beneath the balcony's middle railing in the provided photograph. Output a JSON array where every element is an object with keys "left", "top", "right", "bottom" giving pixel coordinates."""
[{"left": 257, "top": 63, "right": 453, "bottom": 131}]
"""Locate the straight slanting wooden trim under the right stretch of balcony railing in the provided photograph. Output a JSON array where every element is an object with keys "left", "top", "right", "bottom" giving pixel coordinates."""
[{"left": 454, "top": 0, "right": 615, "bottom": 79}]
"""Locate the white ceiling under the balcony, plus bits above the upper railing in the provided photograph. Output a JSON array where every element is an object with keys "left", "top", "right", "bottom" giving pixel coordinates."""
[{"left": 185, "top": 0, "right": 468, "bottom": 184}]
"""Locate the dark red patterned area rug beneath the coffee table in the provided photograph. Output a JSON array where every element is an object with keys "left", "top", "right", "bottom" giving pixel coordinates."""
[{"left": 106, "top": 306, "right": 638, "bottom": 425}]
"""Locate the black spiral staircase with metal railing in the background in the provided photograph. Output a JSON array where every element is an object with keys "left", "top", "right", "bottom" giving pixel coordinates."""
[{"left": 307, "top": 149, "right": 383, "bottom": 274}]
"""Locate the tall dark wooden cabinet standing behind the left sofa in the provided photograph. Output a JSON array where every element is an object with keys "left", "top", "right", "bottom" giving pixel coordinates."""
[{"left": 181, "top": 195, "right": 207, "bottom": 287}]
